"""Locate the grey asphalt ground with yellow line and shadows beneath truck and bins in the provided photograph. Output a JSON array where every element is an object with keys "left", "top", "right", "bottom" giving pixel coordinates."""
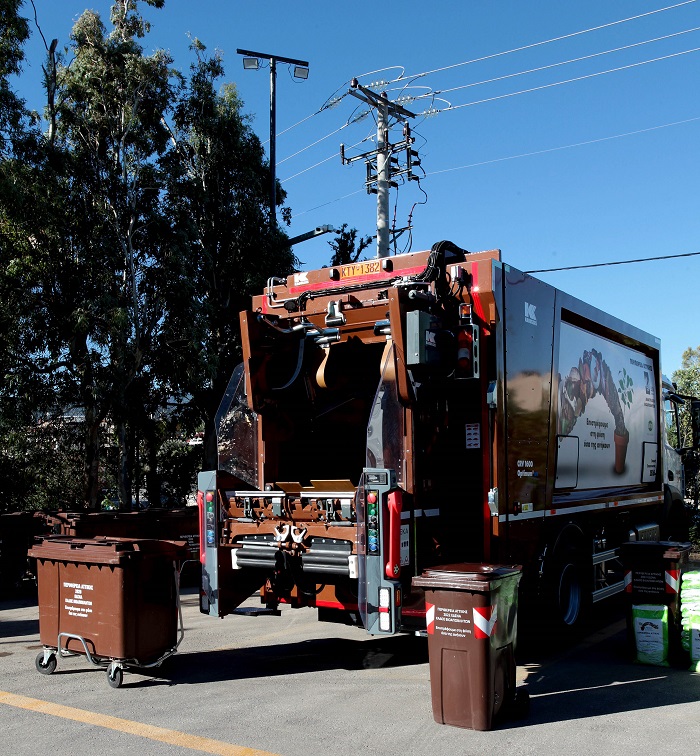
[{"left": 0, "top": 589, "right": 700, "bottom": 756}]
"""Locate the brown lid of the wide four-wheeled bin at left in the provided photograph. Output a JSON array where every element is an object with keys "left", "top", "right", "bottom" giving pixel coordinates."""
[{"left": 29, "top": 536, "right": 188, "bottom": 565}]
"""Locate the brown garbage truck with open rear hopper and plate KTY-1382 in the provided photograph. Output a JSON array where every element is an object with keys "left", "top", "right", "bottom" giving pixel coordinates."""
[{"left": 198, "top": 241, "right": 688, "bottom": 635}]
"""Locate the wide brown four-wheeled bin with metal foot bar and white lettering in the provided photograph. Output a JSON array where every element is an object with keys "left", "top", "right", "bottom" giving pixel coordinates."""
[{"left": 29, "top": 536, "right": 187, "bottom": 687}]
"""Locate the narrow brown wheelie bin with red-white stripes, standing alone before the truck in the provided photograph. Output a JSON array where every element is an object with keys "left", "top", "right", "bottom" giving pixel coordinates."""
[{"left": 413, "top": 563, "right": 527, "bottom": 730}]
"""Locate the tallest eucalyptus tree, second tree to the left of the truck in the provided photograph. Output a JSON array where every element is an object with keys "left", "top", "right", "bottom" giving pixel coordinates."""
[{"left": 44, "top": 0, "right": 174, "bottom": 507}]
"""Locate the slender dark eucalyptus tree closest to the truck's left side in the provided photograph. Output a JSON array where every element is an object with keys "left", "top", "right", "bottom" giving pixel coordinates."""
[{"left": 158, "top": 40, "right": 297, "bottom": 466}]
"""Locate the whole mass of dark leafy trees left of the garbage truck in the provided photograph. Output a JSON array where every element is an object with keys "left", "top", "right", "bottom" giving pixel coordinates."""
[{"left": 0, "top": 0, "right": 296, "bottom": 508}]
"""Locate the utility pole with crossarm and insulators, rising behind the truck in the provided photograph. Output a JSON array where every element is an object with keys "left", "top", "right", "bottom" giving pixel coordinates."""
[{"left": 340, "top": 79, "right": 420, "bottom": 257}]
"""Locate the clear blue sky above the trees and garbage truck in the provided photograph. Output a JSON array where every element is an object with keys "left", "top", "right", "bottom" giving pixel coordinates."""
[{"left": 12, "top": 0, "right": 700, "bottom": 374}]
